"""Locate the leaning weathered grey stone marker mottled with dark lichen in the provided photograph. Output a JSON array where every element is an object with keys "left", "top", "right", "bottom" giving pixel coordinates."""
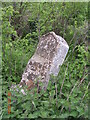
[{"left": 20, "top": 32, "right": 69, "bottom": 90}]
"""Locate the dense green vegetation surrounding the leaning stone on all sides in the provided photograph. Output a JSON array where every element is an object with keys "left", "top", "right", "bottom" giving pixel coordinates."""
[{"left": 2, "top": 2, "right": 90, "bottom": 119}]
